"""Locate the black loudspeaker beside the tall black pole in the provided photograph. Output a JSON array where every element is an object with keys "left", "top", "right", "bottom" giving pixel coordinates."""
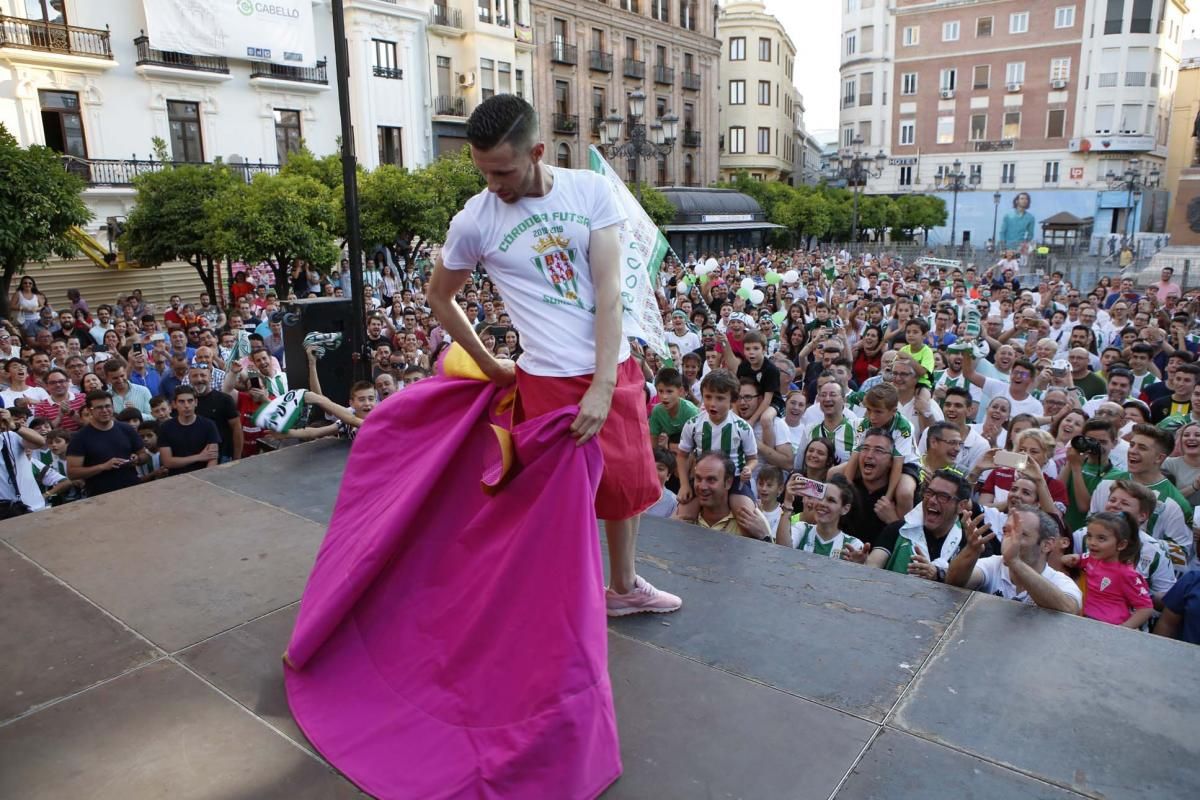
[{"left": 283, "top": 297, "right": 354, "bottom": 405}]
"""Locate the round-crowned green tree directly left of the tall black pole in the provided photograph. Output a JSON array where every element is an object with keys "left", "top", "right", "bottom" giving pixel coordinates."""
[{"left": 204, "top": 174, "right": 341, "bottom": 300}]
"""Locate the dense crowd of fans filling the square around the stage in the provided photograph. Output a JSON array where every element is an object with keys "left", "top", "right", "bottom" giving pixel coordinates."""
[{"left": 0, "top": 244, "right": 1200, "bottom": 643}]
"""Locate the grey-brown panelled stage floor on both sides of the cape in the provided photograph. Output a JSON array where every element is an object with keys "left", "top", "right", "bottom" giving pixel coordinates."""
[{"left": 0, "top": 441, "right": 1200, "bottom": 800}]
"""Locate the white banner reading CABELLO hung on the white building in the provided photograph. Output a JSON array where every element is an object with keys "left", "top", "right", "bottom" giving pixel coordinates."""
[{"left": 142, "top": 0, "right": 317, "bottom": 67}]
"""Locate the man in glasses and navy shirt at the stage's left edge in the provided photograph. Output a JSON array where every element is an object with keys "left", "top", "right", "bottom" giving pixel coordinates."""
[{"left": 67, "top": 389, "right": 150, "bottom": 497}]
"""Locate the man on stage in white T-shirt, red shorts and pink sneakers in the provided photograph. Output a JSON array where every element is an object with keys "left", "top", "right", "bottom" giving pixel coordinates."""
[{"left": 428, "top": 95, "right": 683, "bottom": 616}]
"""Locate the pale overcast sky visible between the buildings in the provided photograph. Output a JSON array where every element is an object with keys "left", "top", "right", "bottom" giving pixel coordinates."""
[{"left": 766, "top": 0, "right": 1200, "bottom": 142}]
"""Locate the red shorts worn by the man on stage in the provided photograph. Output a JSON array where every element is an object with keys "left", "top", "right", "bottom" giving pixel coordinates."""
[{"left": 512, "top": 359, "right": 662, "bottom": 519}]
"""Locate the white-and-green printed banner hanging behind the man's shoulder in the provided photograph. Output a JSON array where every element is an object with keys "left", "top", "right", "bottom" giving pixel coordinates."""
[{"left": 588, "top": 146, "right": 671, "bottom": 359}]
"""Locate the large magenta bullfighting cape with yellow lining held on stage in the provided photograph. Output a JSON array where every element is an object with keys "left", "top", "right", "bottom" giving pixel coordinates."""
[{"left": 284, "top": 347, "right": 622, "bottom": 800}]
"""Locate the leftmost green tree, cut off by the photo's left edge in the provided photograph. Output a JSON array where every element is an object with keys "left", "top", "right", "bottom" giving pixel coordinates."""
[{"left": 0, "top": 124, "right": 91, "bottom": 317}]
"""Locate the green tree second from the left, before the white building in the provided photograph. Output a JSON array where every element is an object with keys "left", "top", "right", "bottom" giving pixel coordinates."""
[{"left": 120, "top": 139, "right": 242, "bottom": 301}]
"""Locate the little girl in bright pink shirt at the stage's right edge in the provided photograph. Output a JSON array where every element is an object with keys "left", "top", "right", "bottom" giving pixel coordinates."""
[{"left": 1062, "top": 511, "right": 1154, "bottom": 628}]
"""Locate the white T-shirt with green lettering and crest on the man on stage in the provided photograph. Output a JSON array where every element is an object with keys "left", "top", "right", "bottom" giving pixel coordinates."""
[{"left": 442, "top": 166, "right": 630, "bottom": 378}]
